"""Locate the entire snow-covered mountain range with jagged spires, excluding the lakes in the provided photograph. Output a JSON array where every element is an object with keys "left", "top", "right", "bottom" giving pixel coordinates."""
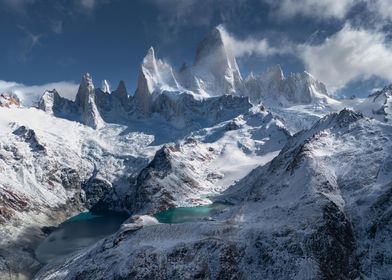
[{"left": 0, "top": 28, "right": 392, "bottom": 279}]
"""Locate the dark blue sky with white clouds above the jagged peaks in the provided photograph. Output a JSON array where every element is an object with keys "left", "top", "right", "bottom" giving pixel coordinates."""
[{"left": 0, "top": 0, "right": 392, "bottom": 99}]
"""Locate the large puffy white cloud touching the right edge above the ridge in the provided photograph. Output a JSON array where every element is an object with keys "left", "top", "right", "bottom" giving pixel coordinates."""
[{"left": 298, "top": 24, "right": 392, "bottom": 92}]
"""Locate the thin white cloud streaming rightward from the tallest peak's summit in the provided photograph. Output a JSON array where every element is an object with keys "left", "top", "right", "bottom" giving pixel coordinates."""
[{"left": 217, "top": 25, "right": 291, "bottom": 57}]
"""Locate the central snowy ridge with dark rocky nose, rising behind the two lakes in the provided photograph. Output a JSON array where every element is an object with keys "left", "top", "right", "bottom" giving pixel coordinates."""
[{"left": 96, "top": 108, "right": 289, "bottom": 213}]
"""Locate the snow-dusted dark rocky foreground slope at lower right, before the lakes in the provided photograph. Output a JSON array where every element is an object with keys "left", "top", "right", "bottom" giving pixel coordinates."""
[{"left": 36, "top": 110, "right": 392, "bottom": 279}]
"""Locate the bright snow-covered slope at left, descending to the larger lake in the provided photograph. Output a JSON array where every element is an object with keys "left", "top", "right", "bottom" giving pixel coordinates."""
[{"left": 0, "top": 108, "right": 159, "bottom": 279}]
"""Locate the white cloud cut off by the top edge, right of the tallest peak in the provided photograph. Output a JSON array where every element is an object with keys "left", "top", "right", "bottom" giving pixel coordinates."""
[{"left": 264, "top": 0, "right": 358, "bottom": 19}]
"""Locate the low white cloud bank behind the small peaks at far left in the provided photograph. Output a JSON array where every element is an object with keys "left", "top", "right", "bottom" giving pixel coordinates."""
[{"left": 0, "top": 80, "right": 79, "bottom": 106}]
